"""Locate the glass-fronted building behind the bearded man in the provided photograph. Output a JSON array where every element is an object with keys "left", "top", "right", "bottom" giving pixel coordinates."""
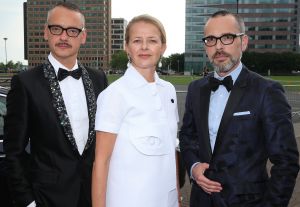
[{"left": 185, "top": 0, "right": 300, "bottom": 74}]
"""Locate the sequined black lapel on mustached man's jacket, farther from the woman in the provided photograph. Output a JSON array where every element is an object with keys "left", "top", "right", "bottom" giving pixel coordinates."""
[{"left": 43, "top": 60, "right": 79, "bottom": 153}]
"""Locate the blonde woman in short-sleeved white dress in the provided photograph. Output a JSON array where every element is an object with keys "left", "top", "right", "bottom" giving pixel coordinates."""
[{"left": 92, "top": 15, "right": 179, "bottom": 207}]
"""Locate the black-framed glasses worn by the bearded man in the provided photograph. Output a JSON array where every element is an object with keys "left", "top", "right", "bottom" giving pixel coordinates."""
[{"left": 202, "top": 33, "right": 244, "bottom": 47}]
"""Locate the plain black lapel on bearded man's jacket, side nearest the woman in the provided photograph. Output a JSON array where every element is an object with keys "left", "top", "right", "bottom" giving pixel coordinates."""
[{"left": 195, "top": 78, "right": 212, "bottom": 159}]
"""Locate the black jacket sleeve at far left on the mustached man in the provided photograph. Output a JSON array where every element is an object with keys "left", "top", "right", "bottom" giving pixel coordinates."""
[{"left": 4, "top": 76, "right": 34, "bottom": 206}]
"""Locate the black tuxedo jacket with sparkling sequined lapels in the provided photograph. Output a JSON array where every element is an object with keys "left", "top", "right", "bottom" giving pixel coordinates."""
[{"left": 4, "top": 62, "right": 107, "bottom": 207}]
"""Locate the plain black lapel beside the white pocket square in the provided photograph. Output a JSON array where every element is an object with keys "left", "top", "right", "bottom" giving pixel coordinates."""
[{"left": 213, "top": 67, "right": 249, "bottom": 154}]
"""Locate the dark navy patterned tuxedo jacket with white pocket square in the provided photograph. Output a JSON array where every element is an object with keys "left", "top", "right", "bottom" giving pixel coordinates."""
[{"left": 180, "top": 67, "right": 299, "bottom": 207}]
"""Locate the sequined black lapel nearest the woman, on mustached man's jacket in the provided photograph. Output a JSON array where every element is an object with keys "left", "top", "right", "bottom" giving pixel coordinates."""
[{"left": 78, "top": 63, "right": 96, "bottom": 152}]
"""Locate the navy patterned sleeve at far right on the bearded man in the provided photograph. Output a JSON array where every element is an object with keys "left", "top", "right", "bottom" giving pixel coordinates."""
[{"left": 261, "top": 83, "right": 299, "bottom": 206}]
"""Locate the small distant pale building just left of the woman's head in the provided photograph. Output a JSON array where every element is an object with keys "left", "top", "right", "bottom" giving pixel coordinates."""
[{"left": 111, "top": 18, "right": 127, "bottom": 54}]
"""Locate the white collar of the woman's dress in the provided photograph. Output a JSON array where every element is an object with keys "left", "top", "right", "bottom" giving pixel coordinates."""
[{"left": 124, "top": 64, "right": 163, "bottom": 88}]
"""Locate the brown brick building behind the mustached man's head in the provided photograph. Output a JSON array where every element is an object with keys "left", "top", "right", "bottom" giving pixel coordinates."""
[{"left": 24, "top": 0, "right": 111, "bottom": 69}]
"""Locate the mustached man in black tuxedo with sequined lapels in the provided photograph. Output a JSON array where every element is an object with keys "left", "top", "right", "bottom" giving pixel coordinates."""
[{"left": 4, "top": 2, "right": 107, "bottom": 207}]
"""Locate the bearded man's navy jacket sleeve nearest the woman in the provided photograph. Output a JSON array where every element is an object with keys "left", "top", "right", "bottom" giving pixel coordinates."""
[{"left": 179, "top": 82, "right": 200, "bottom": 177}]
